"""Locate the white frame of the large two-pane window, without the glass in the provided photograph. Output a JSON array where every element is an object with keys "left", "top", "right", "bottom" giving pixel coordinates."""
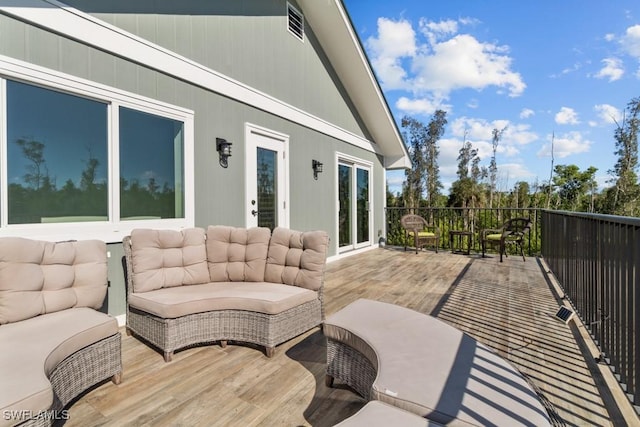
[{"left": 0, "top": 57, "right": 195, "bottom": 243}]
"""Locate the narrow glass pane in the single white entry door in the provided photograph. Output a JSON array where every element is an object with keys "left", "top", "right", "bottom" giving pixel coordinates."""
[{"left": 256, "top": 147, "right": 278, "bottom": 231}]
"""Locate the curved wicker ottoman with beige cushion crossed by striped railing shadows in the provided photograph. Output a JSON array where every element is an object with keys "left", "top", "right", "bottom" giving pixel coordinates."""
[{"left": 323, "top": 299, "right": 550, "bottom": 426}]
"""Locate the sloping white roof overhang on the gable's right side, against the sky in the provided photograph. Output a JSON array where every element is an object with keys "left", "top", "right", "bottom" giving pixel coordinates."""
[{"left": 298, "top": 0, "right": 411, "bottom": 169}]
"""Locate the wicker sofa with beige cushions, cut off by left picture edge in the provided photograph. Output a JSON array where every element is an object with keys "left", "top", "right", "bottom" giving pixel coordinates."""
[{"left": 0, "top": 237, "right": 122, "bottom": 426}]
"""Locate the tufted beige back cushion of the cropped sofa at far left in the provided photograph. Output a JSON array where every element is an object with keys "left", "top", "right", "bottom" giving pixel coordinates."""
[{"left": 0, "top": 237, "right": 107, "bottom": 324}]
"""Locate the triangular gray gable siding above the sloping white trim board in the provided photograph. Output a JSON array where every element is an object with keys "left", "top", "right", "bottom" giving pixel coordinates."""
[{"left": 66, "top": 0, "right": 371, "bottom": 139}]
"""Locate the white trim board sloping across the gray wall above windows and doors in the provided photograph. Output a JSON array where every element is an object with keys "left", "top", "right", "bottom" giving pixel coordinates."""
[{"left": 0, "top": 0, "right": 385, "bottom": 155}]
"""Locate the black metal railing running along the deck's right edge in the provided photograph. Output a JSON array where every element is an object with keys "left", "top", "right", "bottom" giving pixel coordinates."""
[{"left": 542, "top": 211, "right": 640, "bottom": 407}]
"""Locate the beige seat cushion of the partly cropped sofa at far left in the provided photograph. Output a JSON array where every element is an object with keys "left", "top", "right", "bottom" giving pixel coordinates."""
[{"left": 0, "top": 307, "right": 118, "bottom": 426}]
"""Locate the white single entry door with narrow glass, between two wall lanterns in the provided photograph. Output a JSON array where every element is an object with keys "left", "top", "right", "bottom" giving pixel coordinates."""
[{"left": 245, "top": 124, "right": 289, "bottom": 230}]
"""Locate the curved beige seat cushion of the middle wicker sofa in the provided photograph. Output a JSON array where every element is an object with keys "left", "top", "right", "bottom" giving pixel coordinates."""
[{"left": 129, "top": 282, "right": 318, "bottom": 319}]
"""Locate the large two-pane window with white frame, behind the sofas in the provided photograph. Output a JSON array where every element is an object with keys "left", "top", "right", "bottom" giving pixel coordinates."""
[{"left": 0, "top": 69, "right": 193, "bottom": 241}]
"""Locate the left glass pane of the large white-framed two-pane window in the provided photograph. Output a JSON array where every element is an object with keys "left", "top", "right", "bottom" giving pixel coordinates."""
[{"left": 7, "top": 80, "right": 109, "bottom": 224}]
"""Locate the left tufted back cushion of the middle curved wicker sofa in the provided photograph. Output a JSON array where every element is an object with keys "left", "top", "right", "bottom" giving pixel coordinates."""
[{"left": 131, "top": 228, "right": 209, "bottom": 292}]
